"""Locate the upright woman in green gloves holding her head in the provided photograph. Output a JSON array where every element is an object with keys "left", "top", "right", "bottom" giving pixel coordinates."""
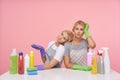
[{"left": 64, "top": 20, "right": 96, "bottom": 70}]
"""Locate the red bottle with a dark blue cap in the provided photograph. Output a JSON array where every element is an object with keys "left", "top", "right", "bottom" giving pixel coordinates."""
[{"left": 18, "top": 51, "right": 24, "bottom": 74}]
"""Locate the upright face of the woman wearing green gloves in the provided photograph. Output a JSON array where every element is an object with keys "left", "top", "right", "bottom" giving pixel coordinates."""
[{"left": 73, "top": 25, "right": 84, "bottom": 38}]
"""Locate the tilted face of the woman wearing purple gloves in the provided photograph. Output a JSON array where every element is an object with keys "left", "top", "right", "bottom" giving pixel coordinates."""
[{"left": 57, "top": 31, "right": 68, "bottom": 44}]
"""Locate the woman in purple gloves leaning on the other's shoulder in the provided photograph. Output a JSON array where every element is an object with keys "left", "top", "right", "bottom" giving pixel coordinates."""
[{"left": 31, "top": 30, "right": 74, "bottom": 70}]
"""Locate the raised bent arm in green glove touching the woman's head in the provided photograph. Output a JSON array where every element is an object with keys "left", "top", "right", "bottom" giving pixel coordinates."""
[{"left": 84, "top": 23, "right": 96, "bottom": 49}]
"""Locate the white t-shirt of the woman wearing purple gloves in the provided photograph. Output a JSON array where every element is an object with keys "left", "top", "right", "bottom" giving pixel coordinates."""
[{"left": 47, "top": 41, "right": 65, "bottom": 62}]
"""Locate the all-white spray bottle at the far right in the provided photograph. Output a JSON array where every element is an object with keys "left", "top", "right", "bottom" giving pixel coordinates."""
[{"left": 102, "top": 47, "right": 110, "bottom": 74}]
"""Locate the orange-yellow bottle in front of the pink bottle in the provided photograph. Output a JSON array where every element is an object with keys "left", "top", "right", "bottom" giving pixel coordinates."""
[{"left": 92, "top": 52, "right": 97, "bottom": 75}]
